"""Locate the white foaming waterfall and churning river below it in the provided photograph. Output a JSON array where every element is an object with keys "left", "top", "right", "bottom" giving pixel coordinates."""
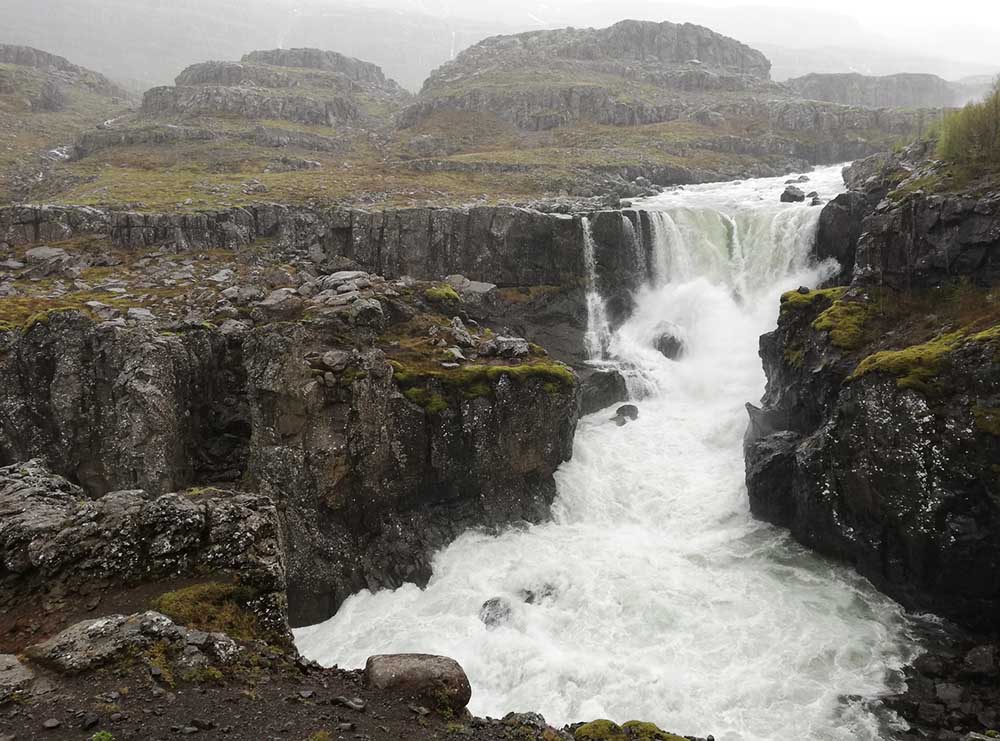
[{"left": 296, "top": 168, "right": 914, "bottom": 741}]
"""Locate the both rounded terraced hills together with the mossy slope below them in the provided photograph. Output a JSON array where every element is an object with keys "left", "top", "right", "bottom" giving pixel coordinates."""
[{"left": 0, "top": 21, "right": 940, "bottom": 210}]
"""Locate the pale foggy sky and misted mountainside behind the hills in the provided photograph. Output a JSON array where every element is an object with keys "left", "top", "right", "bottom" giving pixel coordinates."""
[{"left": 0, "top": 0, "right": 1000, "bottom": 91}]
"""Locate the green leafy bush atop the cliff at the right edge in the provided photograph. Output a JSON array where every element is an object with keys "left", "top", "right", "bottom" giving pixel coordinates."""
[{"left": 938, "top": 80, "right": 1000, "bottom": 171}]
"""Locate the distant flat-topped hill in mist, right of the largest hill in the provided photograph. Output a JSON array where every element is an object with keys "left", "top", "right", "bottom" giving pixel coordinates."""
[{"left": 784, "top": 74, "right": 966, "bottom": 108}]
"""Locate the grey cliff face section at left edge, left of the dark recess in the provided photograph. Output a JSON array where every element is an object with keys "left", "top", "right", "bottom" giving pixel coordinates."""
[{"left": 0, "top": 312, "right": 249, "bottom": 495}]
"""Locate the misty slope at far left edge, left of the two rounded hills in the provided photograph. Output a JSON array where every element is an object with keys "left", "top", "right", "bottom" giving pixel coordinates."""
[{"left": 0, "top": 44, "right": 130, "bottom": 201}]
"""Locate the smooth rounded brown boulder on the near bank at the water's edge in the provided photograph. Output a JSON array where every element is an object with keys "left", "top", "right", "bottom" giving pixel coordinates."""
[{"left": 364, "top": 654, "right": 472, "bottom": 712}]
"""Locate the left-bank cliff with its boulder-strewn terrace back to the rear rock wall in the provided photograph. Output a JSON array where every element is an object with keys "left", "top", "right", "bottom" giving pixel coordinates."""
[{"left": 0, "top": 220, "right": 582, "bottom": 625}]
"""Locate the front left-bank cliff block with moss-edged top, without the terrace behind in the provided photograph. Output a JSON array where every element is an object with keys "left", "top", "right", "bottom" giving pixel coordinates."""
[{"left": 0, "top": 266, "right": 577, "bottom": 625}]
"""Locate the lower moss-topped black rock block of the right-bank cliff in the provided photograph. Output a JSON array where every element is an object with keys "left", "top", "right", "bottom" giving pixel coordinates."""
[{"left": 746, "top": 284, "right": 1000, "bottom": 630}]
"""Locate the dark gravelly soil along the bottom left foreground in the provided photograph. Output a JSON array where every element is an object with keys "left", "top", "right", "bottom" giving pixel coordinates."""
[{"left": 0, "top": 666, "right": 559, "bottom": 741}]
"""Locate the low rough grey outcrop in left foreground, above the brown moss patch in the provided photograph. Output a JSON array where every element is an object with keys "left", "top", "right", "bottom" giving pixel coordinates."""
[{"left": 0, "top": 460, "right": 288, "bottom": 636}]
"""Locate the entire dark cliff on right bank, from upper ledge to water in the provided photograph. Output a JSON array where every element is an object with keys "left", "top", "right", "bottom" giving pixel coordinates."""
[{"left": 746, "top": 147, "right": 1000, "bottom": 631}]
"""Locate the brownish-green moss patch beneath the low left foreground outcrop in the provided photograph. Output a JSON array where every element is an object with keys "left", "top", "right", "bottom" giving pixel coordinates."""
[{"left": 153, "top": 582, "right": 262, "bottom": 641}]
